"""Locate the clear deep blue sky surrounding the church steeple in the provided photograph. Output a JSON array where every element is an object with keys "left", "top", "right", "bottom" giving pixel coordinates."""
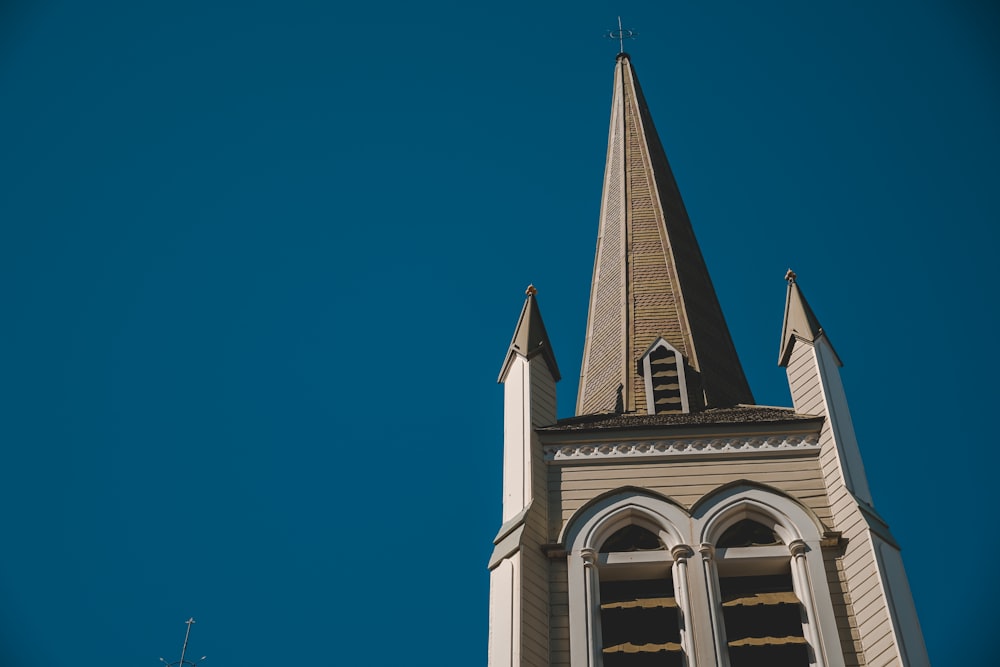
[{"left": 0, "top": 0, "right": 1000, "bottom": 667}]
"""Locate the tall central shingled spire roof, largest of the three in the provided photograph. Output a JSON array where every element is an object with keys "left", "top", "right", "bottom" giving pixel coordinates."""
[{"left": 576, "top": 53, "right": 753, "bottom": 415}]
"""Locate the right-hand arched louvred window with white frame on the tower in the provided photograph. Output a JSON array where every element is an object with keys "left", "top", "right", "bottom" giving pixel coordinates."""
[{"left": 695, "top": 486, "right": 843, "bottom": 667}]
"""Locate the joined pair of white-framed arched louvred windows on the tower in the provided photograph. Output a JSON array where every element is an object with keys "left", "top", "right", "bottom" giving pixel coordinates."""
[{"left": 560, "top": 484, "right": 844, "bottom": 667}]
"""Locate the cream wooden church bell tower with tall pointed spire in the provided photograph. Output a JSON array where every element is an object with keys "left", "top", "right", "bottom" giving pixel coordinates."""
[{"left": 489, "top": 53, "right": 929, "bottom": 667}]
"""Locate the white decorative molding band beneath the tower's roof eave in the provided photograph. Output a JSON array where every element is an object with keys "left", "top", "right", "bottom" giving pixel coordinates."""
[{"left": 542, "top": 433, "right": 820, "bottom": 463}]
